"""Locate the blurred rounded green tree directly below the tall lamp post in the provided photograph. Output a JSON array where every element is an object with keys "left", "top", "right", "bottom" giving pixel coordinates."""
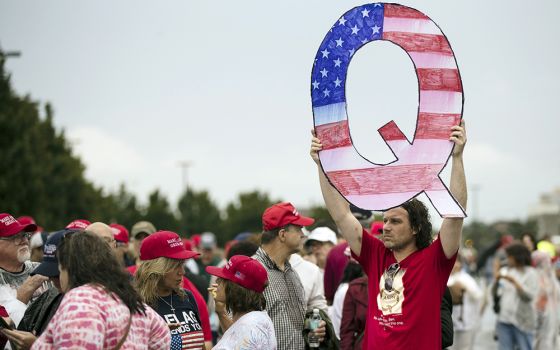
[{"left": 177, "top": 188, "right": 222, "bottom": 236}]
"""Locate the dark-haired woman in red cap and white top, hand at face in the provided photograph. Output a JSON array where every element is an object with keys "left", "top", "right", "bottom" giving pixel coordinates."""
[{"left": 206, "top": 255, "right": 276, "bottom": 350}]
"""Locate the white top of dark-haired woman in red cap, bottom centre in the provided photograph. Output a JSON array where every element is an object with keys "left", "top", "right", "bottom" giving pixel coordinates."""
[{"left": 212, "top": 311, "right": 276, "bottom": 350}]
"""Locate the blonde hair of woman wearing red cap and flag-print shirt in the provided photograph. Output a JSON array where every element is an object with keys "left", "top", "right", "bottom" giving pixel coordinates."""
[{"left": 134, "top": 257, "right": 186, "bottom": 308}]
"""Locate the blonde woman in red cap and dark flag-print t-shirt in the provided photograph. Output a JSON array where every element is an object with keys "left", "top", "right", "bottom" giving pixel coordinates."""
[{"left": 135, "top": 231, "right": 206, "bottom": 350}]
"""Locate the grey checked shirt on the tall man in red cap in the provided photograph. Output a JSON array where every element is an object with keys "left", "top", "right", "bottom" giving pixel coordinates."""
[{"left": 253, "top": 248, "right": 305, "bottom": 350}]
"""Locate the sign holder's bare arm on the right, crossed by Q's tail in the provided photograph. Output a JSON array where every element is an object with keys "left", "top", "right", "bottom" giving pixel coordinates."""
[{"left": 440, "top": 120, "right": 467, "bottom": 258}]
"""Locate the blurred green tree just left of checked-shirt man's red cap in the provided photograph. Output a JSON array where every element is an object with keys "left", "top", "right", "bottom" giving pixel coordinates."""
[{"left": 221, "top": 190, "right": 279, "bottom": 241}]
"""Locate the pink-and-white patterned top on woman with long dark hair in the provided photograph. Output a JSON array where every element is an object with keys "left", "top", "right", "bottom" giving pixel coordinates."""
[{"left": 31, "top": 284, "right": 171, "bottom": 350}]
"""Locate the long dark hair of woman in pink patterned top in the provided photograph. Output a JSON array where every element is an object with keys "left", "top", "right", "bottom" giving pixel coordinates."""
[{"left": 56, "top": 231, "right": 146, "bottom": 314}]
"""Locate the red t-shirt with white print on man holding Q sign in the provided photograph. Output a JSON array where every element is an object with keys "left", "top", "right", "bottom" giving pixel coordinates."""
[{"left": 353, "top": 230, "right": 457, "bottom": 350}]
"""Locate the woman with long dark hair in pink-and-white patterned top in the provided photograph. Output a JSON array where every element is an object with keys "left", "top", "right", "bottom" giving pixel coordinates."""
[{"left": 32, "top": 231, "right": 171, "bottom": 349}]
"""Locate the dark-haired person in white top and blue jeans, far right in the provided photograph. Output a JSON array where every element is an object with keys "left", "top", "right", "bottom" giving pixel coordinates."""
[{"left": 495, "top": 243, "right": 538, "bottom": 350}]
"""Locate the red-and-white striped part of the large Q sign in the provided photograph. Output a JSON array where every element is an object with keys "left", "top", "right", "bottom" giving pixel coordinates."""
[{"left": 314, "top": 4, "right": 465, "bottom": 217}]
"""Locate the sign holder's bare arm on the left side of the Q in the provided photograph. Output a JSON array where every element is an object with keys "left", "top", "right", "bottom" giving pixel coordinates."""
[{"left": 310, "top": 131, "right": 362, "bottom": 256}]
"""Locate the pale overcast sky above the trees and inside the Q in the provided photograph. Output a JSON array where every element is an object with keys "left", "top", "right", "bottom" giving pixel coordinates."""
[{"left": 0, "top": 0, "right": 560, "bottom": 227}]
